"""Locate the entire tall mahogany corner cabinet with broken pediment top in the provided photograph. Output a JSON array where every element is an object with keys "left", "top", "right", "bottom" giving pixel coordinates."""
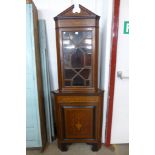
[{"left": 53, "top": 5, "right": 103, "bottom": 151}]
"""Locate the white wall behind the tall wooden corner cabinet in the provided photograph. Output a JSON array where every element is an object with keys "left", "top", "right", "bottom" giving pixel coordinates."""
[{"left": 34, "top": 0, "right": 113, "bottom": 142}]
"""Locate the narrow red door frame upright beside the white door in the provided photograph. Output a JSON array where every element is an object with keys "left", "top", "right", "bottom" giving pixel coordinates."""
[{"left": 105, "top": 0, "right": 120, "bottom": 147}]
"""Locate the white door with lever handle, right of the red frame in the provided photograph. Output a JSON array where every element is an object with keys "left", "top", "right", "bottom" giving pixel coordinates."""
[{"left": 111, "top": 0, "right": 129, "bottom": 144}]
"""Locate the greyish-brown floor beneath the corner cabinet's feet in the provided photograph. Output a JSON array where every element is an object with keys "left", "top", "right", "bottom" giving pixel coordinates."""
[{"left": 26, "top": 141, "right": 129, "bottom": 155}]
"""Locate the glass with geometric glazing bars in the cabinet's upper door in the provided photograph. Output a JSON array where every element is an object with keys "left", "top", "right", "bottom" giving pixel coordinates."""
[{"left": 62, "top": 31, "right": 92, "bottom": 86}]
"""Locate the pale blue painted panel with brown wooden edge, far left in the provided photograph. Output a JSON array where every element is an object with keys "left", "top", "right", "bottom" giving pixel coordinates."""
[{"left": 26, "top": 0, "right": 46, "bottom": 148}]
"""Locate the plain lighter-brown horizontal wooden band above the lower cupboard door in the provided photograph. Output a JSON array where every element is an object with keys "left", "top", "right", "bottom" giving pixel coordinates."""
[{"left": 57, "top": 96, "right": 99, "bottom": 103}]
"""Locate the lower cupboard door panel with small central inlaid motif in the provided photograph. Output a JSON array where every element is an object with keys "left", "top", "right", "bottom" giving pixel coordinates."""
[{"left": 61, "top": 106, "right": 96, "bottom": 139}]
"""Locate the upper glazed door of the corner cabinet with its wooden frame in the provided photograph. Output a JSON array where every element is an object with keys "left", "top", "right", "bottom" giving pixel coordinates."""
[{"left": 58, "top": 28, "right": 97, "bottom": 90}]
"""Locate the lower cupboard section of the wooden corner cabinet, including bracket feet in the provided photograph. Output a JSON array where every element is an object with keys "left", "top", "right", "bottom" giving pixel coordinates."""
[{"left": 53, "top": 90, "right": 103, "bottom": 151}]
